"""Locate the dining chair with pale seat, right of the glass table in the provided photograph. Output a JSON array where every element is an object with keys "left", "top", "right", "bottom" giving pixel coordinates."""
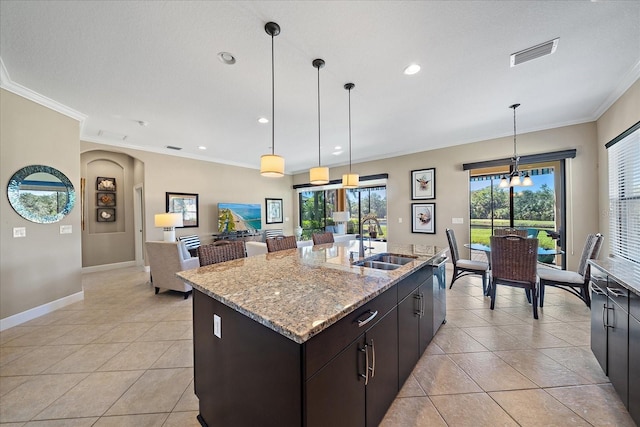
[{"left": 538, "top": 233, "right": 604, "bottom": 308}]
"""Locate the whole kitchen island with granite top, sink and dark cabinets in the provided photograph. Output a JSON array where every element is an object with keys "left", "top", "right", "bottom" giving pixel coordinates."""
[{"left": 178, "top": 241, "right": 446, "bottom": 427}]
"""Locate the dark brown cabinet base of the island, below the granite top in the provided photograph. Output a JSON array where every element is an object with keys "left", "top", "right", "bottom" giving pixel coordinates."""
[{"left": 193, "top": 256, "right": 446, "bottom": 427}]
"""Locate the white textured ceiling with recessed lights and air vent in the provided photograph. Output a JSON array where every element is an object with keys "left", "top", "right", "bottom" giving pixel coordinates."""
[{"left": 0, "top": 0, "right": 640, "bottom": 173}]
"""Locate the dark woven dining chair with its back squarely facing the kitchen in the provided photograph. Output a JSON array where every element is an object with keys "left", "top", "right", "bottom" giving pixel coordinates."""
[{"left": 490, "top": 235, "right": 538, "bottom": 319}]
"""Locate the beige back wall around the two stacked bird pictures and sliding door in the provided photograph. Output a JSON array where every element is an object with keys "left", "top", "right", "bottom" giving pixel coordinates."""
[{"left": 294, "top": 123, "right": 599, "bottom": 268}]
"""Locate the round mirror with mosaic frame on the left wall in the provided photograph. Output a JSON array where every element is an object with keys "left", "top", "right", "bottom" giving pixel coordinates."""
[{"left": 7, "top": 165, "right": 76, "bottom": 224}]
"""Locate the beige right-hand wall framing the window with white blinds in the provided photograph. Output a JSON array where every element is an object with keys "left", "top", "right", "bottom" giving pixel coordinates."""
[{"left": 597, "top": 80, "right": 640, "bottom": 258}]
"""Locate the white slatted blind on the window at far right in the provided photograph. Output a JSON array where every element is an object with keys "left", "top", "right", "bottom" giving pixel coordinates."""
[{"left": 607, "top": 120, "right": 640, "bottom": 264}]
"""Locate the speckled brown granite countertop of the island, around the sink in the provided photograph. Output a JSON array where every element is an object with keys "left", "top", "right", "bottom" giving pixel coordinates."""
[{"left": 178, "top": 240, "right": 447, "bottom": 343}]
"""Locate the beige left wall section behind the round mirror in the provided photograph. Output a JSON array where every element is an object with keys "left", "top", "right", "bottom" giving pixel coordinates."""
[{"left": 0, "top": 89, "right": 82, "bottom": 319}]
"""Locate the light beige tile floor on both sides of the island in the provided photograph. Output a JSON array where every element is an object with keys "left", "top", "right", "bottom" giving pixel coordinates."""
[{"left": 0, "top": 268, "right": 635, "bottom": 427}]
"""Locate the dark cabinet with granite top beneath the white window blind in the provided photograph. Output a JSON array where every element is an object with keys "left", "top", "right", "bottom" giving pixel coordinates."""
[{"left": 590, "top": 259, "right": 640, "bottom": 425}]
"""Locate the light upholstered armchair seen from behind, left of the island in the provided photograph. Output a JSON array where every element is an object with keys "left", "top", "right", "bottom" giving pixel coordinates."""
[{"left": 145, "top": 242, "right": 200, "bottom": 299}]
